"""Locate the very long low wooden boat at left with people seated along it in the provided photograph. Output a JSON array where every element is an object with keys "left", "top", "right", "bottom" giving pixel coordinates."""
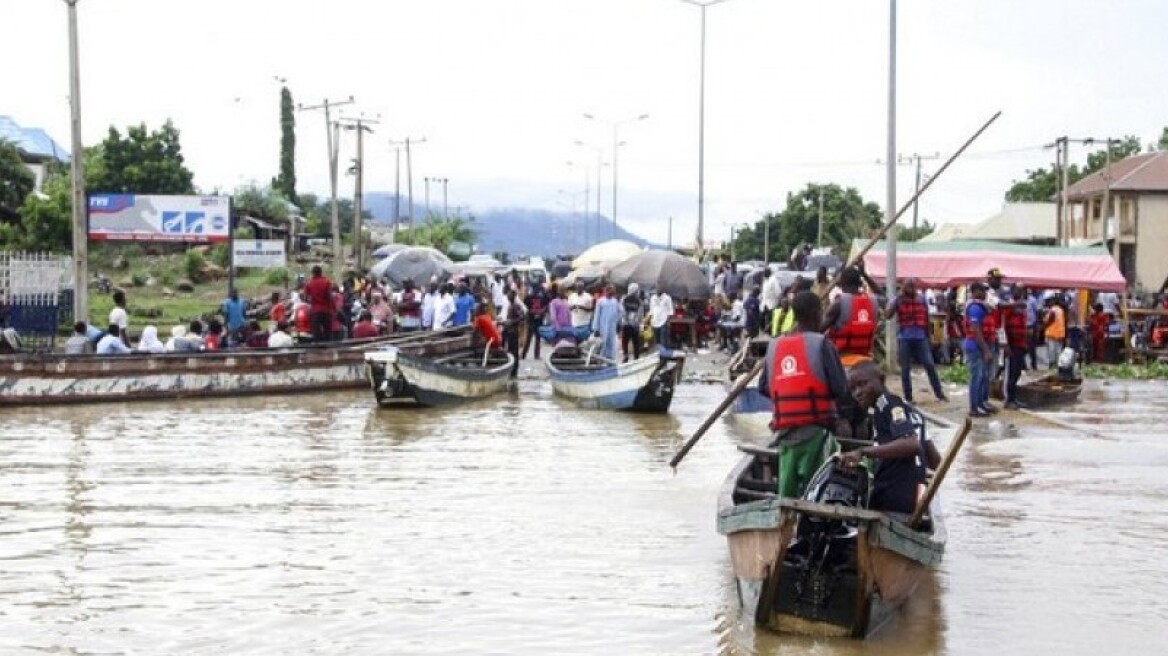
[{"left": 0, "top": 330, "right": 472, "bottom": 406}]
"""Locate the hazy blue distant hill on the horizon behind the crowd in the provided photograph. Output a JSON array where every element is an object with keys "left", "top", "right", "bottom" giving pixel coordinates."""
[{"left": 364, "top": 191, "right": 649, "bottom": 258}]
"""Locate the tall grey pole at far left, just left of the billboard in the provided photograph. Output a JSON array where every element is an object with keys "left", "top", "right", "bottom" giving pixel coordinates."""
[{"left": 65, "top": 0, "right": 89, "bottom": 322}]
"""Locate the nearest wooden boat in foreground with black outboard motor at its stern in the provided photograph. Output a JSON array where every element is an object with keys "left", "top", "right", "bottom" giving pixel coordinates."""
[{"left": 717, "top": 434, "right": 946, "bottom": 637}]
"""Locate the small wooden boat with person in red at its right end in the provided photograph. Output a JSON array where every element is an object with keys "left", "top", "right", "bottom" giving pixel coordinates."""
[{"left": 364, "top": 344, "right": 515, "bottom": 406}]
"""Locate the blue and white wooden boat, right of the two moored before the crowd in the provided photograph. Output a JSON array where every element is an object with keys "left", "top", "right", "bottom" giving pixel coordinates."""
[{"left": 544, "top": 349, "right": 686, "bottom": 412}]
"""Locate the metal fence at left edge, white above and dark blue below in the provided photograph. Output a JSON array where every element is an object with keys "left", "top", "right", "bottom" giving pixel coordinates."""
[{"left": 0, "top": 251, "right": 74, "bottom": 351}]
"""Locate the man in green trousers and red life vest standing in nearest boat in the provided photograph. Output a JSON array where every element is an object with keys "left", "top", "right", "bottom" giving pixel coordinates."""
[{"left": 758, "top": 292, "right": 855, "bottom": 497}]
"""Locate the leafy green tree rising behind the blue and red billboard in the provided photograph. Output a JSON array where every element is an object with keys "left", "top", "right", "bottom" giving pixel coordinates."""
[{"left": 85, "top": 120, "right": 195, "bottom": 194}]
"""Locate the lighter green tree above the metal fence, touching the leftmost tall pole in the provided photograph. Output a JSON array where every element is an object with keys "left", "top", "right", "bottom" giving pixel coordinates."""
[{"left": 0, "top": 167, "right": 72, "bottom": 252}]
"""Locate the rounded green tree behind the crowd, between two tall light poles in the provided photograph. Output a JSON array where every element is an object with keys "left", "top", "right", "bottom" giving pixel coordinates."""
[{"left": 734, "top": 183, "right": 884, "bottom": 261}]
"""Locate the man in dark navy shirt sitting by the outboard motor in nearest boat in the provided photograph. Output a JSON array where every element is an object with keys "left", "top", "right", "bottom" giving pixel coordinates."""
[{"left": 840, "top": 361, "right": 941, "bottom": 515}]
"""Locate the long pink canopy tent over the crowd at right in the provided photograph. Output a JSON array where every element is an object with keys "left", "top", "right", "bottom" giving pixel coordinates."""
[{"left": 851, "top": 239, "right": 1127, "bottom": 292}]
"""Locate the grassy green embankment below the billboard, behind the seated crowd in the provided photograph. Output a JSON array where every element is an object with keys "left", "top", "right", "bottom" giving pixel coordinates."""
[{"left": 89, "top": 244, "right": 311, "bottom": 335}]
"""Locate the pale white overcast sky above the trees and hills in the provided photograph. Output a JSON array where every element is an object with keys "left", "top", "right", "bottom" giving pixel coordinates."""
[{"left": 0, "top": 0, "right": 1168, "bottom": 244}]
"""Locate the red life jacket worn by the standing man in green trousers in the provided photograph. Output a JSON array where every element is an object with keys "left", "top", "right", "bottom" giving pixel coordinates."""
[{"left": 770, "top": 333, "right": 837, "bottom": 431}]
